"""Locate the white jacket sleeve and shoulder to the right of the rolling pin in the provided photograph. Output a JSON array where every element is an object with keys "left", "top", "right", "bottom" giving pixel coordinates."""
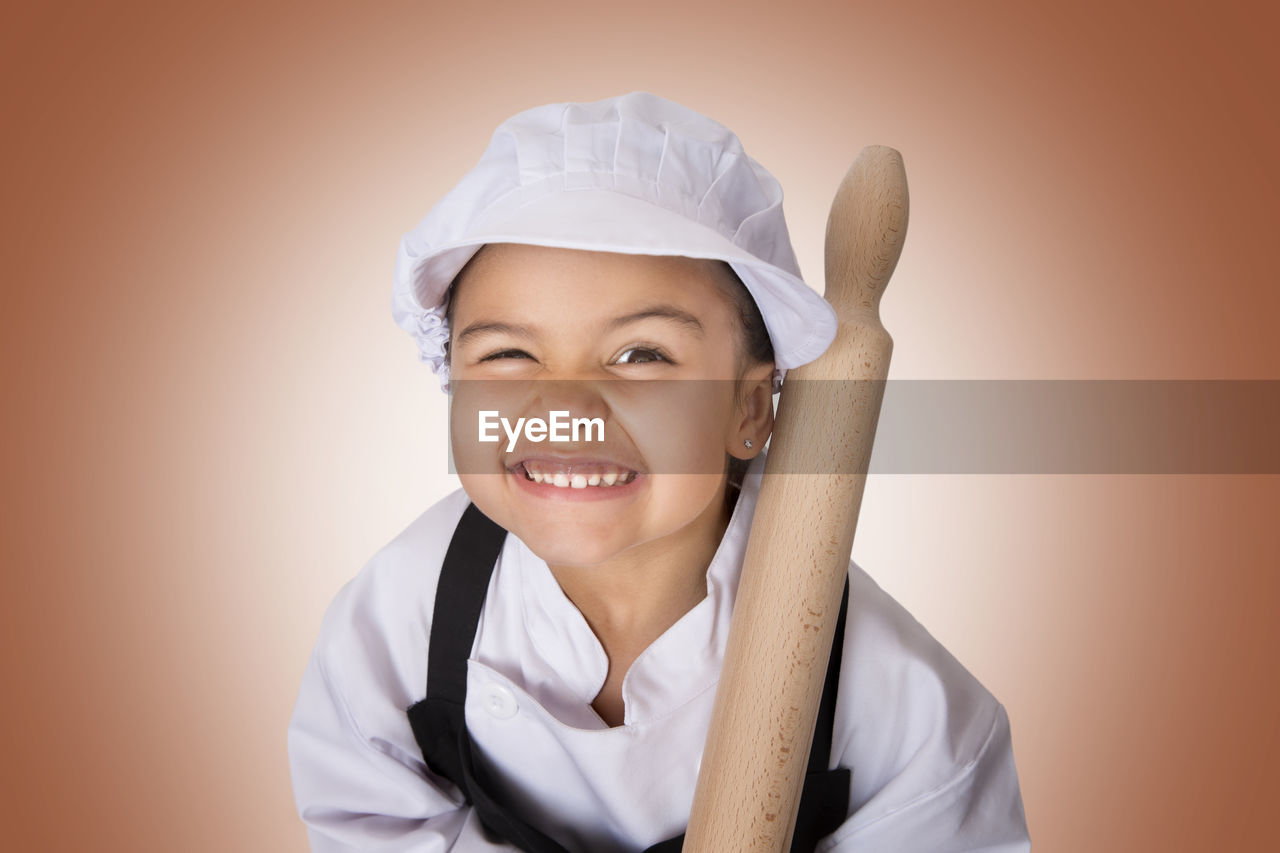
[{"left": 818, "top": 562, "right": 1030, "bottom": 853}]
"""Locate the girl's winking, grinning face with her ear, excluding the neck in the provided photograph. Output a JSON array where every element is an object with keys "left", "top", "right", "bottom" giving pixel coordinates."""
[{"left": 449, "top": 243, "right": 773, "bottom": 566}]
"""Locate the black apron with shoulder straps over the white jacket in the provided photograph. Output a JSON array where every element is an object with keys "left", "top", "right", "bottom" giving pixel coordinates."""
[{"left": 408, "top": 503, "right": 850, "bottom": 853}]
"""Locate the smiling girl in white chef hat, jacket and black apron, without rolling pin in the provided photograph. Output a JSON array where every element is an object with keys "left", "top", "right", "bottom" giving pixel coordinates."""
[{"left": 289, "top": 92, "right": 1029, "bottom": 853}]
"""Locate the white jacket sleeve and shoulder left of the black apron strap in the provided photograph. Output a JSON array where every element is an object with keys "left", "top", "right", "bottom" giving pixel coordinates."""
[{"left": 288, "top": 489, "right": 488, "bottom": 829}]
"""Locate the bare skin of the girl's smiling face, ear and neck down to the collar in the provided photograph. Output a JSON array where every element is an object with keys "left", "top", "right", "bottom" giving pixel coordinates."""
[{"left": 451, "top": 243, "right": 773, "bottom": 726}]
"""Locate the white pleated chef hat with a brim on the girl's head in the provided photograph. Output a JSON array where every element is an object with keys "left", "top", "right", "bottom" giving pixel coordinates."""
[{"left": 392, "top": 92, "right": 836, "bottom": 391}]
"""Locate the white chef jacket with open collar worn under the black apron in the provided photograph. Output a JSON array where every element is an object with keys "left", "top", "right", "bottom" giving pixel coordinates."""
[{"left": 288, "top": 455, "right": 1030, "bottom": 853}]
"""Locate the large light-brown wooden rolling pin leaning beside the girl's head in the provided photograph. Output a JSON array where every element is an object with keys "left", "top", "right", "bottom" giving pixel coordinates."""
[{"left": 684, "top": 146, "right": 908, "bottom": 853}]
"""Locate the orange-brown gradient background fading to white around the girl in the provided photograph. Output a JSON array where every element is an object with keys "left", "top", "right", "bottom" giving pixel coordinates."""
[{"left": 0, "top": 0, "right": 1280, "bottom": 853}]
